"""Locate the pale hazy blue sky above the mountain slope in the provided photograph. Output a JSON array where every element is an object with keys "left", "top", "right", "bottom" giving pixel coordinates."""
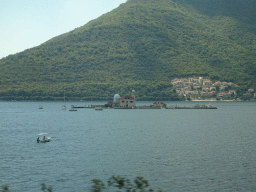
[{"left": 0, "top": 0, "right": 126, "bottom": 59}]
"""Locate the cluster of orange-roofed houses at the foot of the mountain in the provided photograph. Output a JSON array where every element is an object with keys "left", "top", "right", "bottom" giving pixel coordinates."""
[{"left": 171, "top": 77, "right": 256, "bottom": 101}]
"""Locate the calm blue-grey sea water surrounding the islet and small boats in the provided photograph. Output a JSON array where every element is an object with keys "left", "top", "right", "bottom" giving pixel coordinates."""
[{"left": 0, "top": 102, "right": 256, "bottom": 192}]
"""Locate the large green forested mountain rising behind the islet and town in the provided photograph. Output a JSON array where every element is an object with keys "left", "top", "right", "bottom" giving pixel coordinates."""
[{"left": 0, "top": 0, "right": 256, "bottom": 100}]
